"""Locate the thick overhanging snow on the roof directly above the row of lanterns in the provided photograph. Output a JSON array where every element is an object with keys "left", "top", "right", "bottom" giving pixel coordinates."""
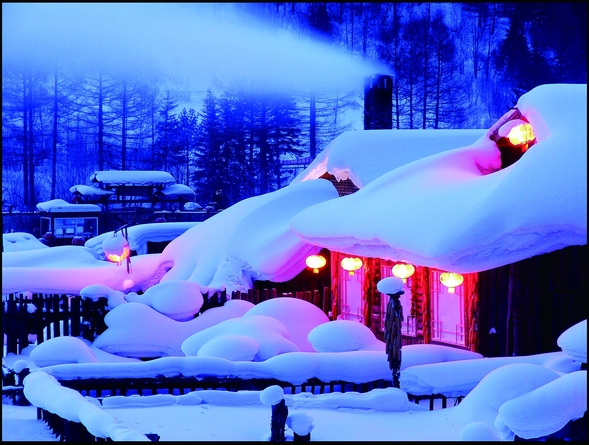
[{"left": 291, "top": 85, "right": 587, "bottom": 272}]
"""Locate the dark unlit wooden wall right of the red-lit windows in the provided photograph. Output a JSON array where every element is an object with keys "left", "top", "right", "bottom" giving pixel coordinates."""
[{"left": 478, "top": 245, "right": 588, "bottom": 357}]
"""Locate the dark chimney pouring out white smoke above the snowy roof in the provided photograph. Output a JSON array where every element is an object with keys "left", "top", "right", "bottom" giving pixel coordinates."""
[{"left": 364, "top": 74, "right": 393, "bottom": 130}]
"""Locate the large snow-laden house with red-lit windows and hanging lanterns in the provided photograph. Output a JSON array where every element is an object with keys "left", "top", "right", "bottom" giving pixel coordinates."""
[{"left": 282, "top": 85, "right": 587, "bottom": 355}]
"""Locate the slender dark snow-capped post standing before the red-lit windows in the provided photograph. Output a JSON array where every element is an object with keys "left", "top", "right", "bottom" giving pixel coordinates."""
[{"left": 376, "top": 277, "right": 405, "bottom": 388}]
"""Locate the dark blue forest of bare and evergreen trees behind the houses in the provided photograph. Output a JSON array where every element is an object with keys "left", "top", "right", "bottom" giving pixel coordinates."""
[{"left": 2, "top": 2, "right": 587, "bottom": 211}]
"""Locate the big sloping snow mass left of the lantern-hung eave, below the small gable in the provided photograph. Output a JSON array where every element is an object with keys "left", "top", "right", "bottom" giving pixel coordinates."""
[{"left": 162, "top": 180, "right": 338, "bottom": 292}]
